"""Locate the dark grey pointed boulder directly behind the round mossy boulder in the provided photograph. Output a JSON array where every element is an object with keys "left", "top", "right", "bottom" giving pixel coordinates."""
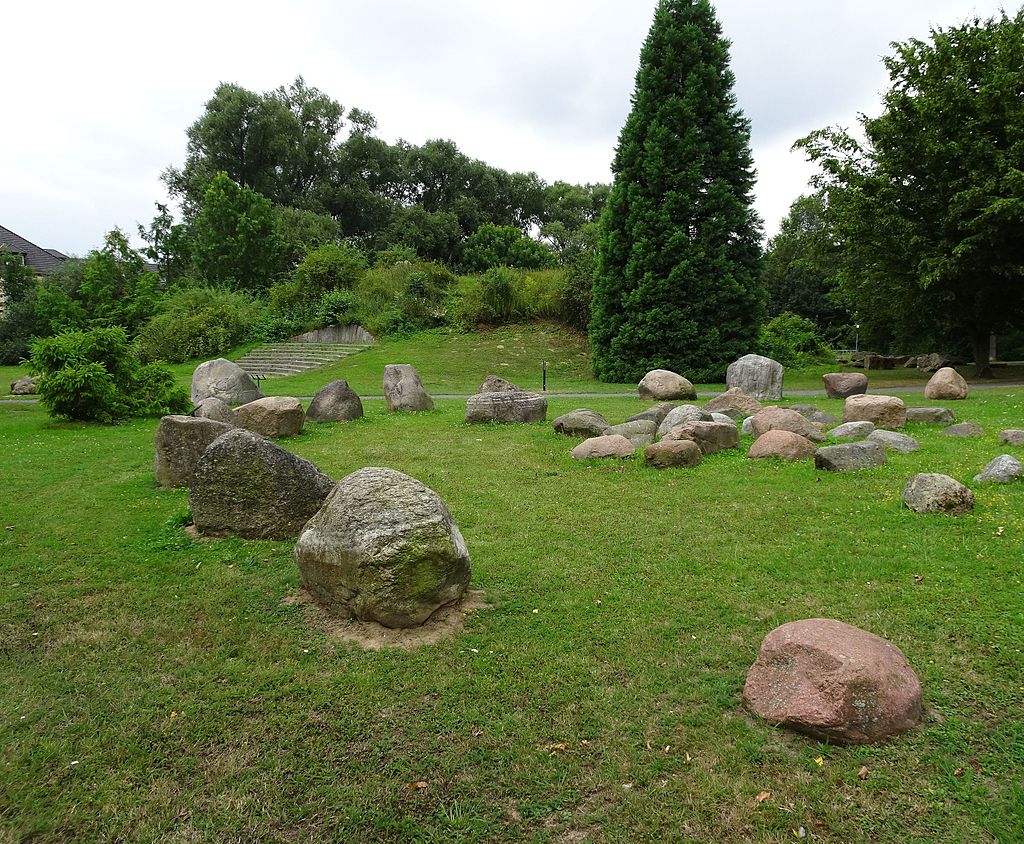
[{"left": 188, "top": 428, "right": 334, "bottom": 539}]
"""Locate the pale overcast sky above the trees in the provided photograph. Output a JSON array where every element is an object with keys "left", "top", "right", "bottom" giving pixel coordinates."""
[{"left": 0, "top": 0, "right": 1016, "bottom": 254}]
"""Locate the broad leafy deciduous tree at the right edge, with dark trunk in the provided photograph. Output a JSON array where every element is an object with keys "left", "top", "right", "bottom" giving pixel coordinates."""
[{"left": 799, "top": 10, "right": 1024, "bottom": 374}]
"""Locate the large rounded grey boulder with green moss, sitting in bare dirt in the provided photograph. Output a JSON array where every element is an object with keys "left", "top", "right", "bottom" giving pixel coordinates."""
[{"left": 295, "top": 468, "right": 470, "bottom": 628}]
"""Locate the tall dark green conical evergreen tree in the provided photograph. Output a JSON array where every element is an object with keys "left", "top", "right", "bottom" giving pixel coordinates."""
[{"left": 590, "top": 0, "right": 763, "bottom": 382}]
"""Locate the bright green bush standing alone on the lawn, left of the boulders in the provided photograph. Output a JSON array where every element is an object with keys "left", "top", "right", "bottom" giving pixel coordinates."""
[{"left": 29, "top": 327, "right": 189, "bottom": 423}]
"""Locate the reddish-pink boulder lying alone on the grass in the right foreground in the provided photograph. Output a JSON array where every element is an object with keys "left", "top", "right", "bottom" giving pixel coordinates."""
[{"left": 743, "top": 619, "right": 924, "bottom": 745}]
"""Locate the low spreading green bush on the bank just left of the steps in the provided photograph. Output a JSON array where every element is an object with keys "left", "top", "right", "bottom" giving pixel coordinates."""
[{"left": 136, "top": 287, "right": 267, "bottom": 363}]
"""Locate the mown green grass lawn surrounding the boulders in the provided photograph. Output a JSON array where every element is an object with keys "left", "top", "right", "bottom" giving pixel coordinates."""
[{"left": 0, "top": 381, "right": 1024, "bottom": 842}]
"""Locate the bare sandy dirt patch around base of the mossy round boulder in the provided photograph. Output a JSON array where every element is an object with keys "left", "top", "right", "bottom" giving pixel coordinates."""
[{"left": 282, "top": 589, "right": 490, "bottom": 650}]
